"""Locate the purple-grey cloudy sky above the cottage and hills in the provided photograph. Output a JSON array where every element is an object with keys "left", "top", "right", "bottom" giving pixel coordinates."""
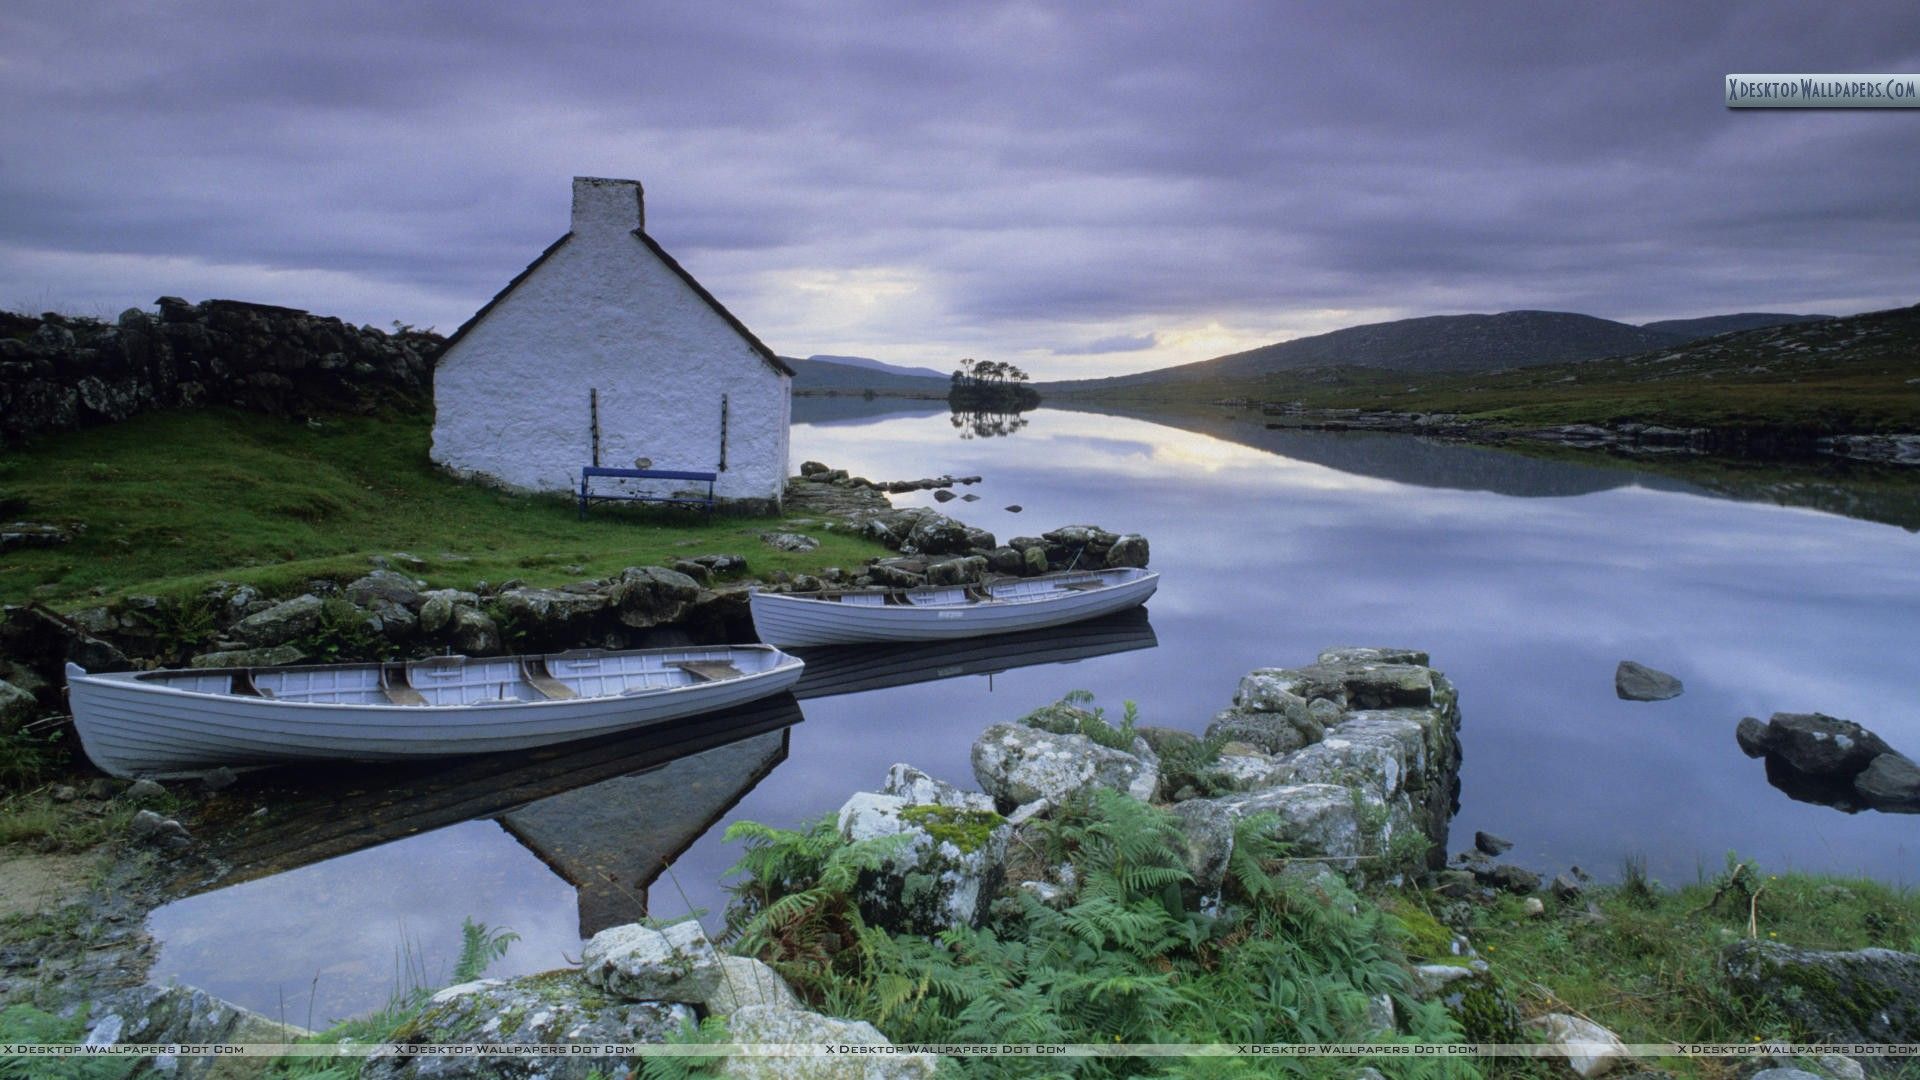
[{"left": 0, "top": 0, "right": 1920, "bottom": 377}]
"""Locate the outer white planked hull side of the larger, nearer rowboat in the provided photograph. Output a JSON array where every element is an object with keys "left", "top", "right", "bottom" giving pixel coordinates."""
[{"left": 67, "top": 645, "right": 804, "bottom": 778}]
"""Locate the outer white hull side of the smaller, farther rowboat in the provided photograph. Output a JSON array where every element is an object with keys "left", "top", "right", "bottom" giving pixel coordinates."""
[{"left": 751, "top": 571, "right": 1160, "bottom": 648}]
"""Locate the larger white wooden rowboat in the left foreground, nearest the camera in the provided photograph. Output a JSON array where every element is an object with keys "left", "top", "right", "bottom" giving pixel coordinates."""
[{"left": 67, "top": 646, "right": 804, "bottom": 778}]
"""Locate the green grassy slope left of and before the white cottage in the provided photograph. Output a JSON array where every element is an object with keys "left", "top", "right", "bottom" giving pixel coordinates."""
[{"left": 0, "top": 409, "right": 885, "bottom": 607}]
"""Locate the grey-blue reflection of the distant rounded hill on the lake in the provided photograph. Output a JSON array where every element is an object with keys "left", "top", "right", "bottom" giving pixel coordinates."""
[{"left": 1064, "top": 404, "right": 1697, "bottom": 498}]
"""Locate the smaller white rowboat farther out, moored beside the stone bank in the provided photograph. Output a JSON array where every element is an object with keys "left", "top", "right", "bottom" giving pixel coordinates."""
[{"left": 749, "top": 567, "right": 1160, "bottom": 648}]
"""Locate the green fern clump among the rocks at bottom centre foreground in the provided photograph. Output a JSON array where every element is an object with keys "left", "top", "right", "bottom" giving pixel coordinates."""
[{"left": 714, "top": 790, "right": 1475, "bottom": 1076}]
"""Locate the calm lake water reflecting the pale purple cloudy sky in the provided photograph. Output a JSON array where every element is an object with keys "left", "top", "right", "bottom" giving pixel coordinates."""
[{"left": 152, "top": 400, "right": 1920, "bottom": 1022}]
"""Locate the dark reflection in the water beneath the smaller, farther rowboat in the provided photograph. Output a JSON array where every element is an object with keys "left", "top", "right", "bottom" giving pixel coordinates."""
[{"left": 793, "top": 607, "right": 1160, "bottom": 701}]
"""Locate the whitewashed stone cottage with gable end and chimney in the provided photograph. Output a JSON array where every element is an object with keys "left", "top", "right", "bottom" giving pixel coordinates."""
[{"left": 432, "top": 177, "right": 793, "bottom": 502}]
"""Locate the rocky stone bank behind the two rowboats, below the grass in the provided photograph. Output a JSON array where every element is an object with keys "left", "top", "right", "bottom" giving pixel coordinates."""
[{"left": 0, "top": 461, "right": 1150, "bottom": 745}]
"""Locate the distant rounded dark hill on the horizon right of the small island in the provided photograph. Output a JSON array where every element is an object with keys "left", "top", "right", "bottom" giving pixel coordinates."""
[{"left": 1041, "top": 311, "right": 1820, "bottom": 392}]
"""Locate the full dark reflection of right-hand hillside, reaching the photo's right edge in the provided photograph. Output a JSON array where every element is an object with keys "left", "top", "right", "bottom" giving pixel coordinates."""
[{"left": 1058, "top": 402, "right": 1920, "bottom": 532}]
